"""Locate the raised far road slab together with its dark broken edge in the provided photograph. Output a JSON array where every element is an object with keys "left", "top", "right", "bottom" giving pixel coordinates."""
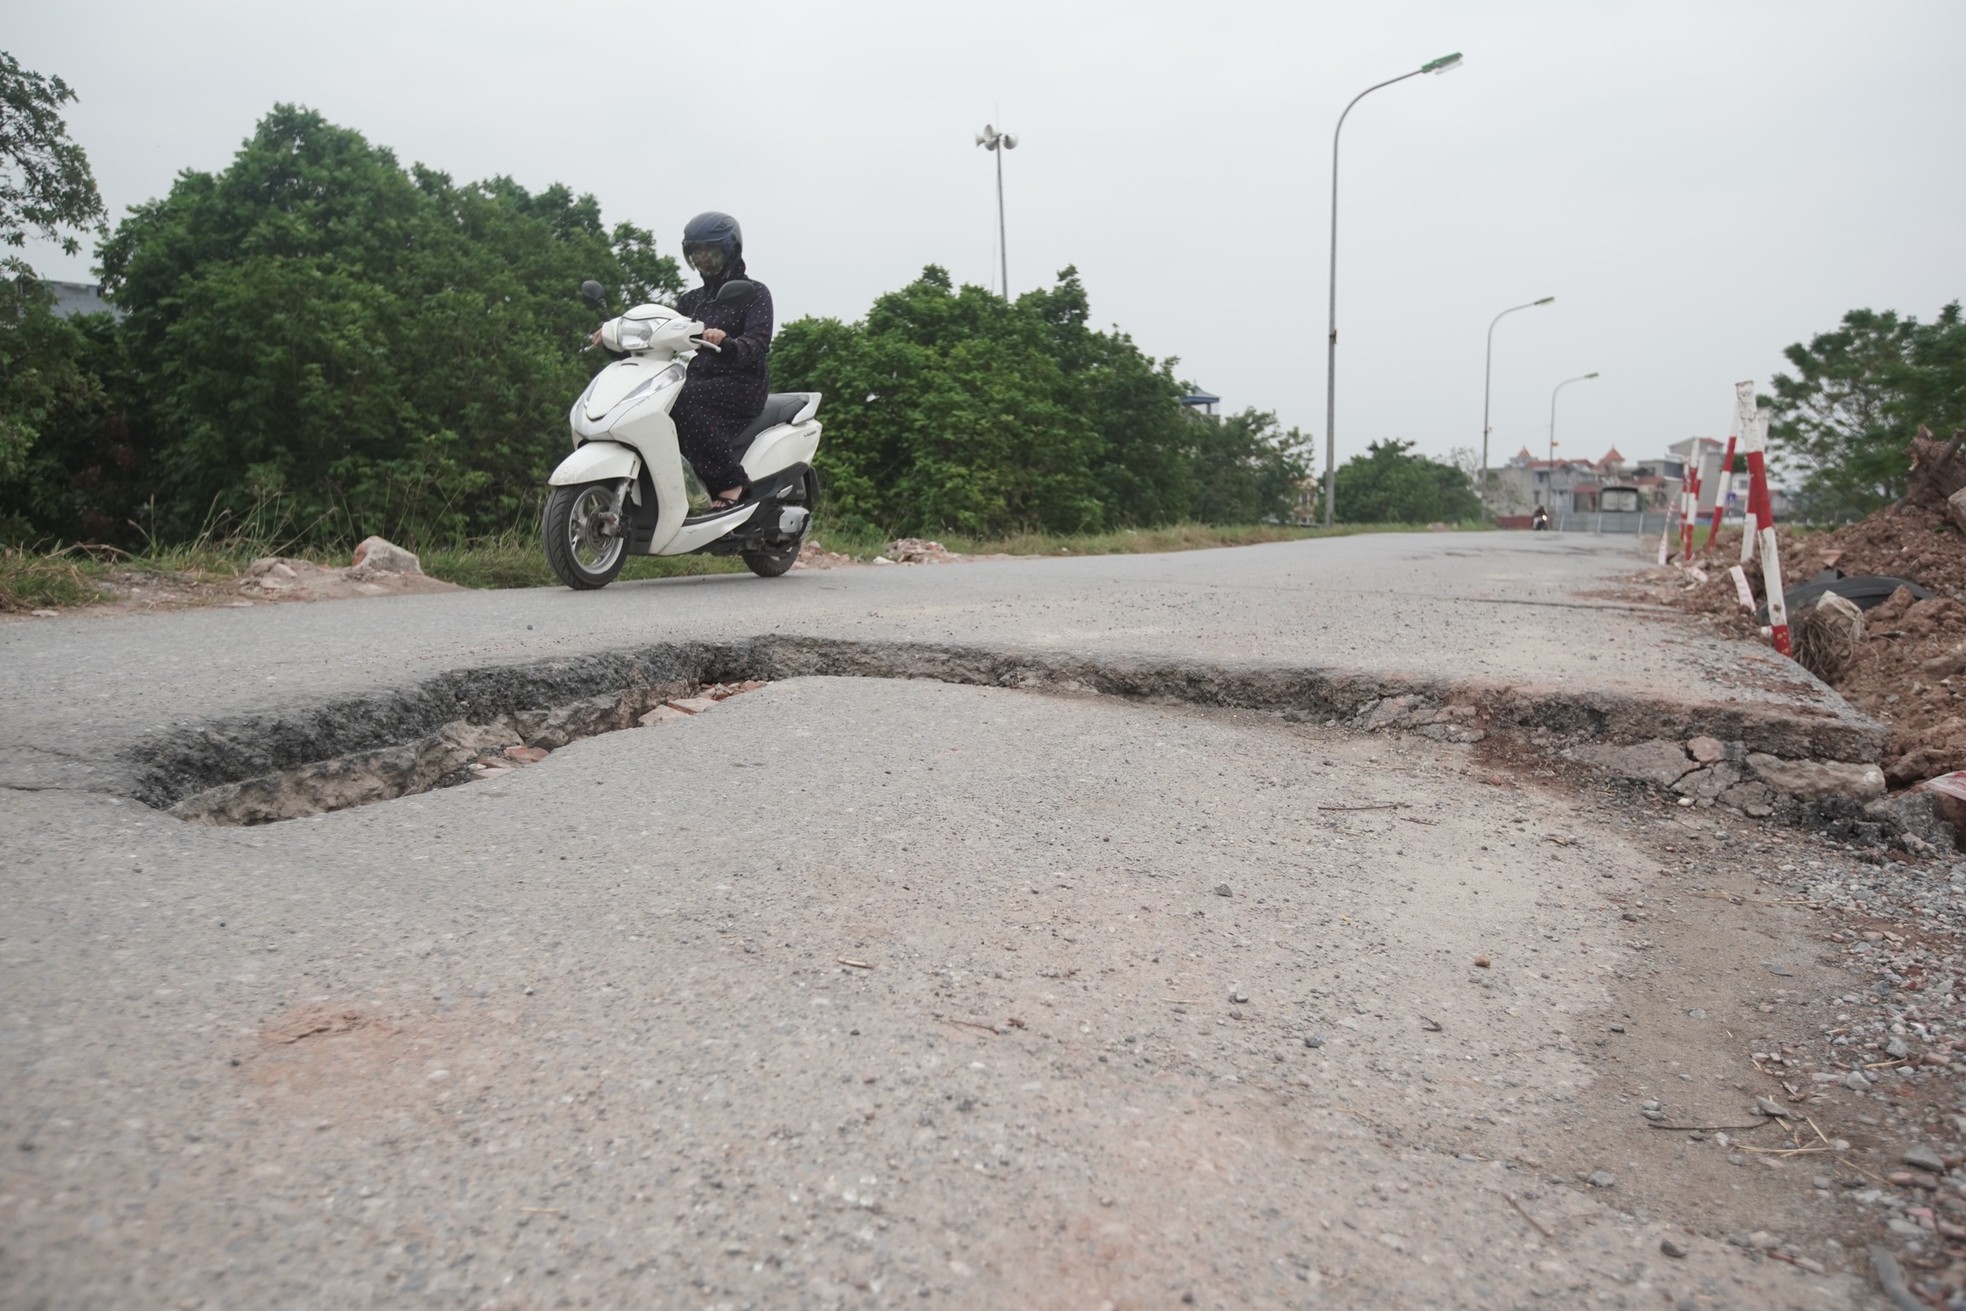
[{"left": 0, "top": 533, "right": 1883, "bottom": 800}]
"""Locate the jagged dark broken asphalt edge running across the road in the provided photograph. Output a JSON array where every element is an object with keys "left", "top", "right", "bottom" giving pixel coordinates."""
[{"left": 92, "top": 635, "right": 1887, "bottom": 810}]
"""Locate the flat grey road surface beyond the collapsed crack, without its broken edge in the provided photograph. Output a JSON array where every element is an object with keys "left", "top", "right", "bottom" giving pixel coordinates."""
[{"left": 0, "top": 533, "right": 1850, "bottom": 801}]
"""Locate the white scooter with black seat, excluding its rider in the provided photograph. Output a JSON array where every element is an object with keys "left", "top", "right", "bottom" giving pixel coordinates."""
[{"left": 541, "top": 281, "right": 820, "bottom": 590}]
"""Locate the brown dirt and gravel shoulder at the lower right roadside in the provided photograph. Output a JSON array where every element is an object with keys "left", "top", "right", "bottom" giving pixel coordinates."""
[{"left": 1516, "top": 754, "right": 1966, "bottom": 1307}]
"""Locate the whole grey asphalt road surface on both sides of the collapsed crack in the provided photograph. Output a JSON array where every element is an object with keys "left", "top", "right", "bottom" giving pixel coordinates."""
[{"left": 0, "top": 535, "right": 1862, "bottom": 1309}]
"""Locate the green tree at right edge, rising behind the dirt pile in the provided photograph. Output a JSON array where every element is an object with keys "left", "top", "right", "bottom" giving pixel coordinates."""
[{"left": 1762, "top": 301, "right": 1966, "bottom": 519}]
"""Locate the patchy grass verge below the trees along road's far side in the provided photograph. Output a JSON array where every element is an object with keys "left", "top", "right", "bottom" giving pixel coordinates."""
[{"left": 0, "top": 513, "right": 1488, "bottom": 613}]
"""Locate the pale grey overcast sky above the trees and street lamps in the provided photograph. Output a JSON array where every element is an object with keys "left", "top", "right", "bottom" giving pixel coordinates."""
[{"left": 15, "top": 0, "right": 1966, "bottom": 477}]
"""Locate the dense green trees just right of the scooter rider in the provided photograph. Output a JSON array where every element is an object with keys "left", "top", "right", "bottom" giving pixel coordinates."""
[{"left": 773, "top": 265, "right": 1266, "bottom": 535}]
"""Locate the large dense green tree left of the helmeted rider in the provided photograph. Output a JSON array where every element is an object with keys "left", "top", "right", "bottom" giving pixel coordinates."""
[{"left": 102, "top": 106, "right": 680, "bottom": 541}]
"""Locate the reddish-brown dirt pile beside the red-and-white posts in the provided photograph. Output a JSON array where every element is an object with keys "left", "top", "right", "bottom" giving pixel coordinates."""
[{"left": 1665, "top": 436, "right": 1966, "bottom": 788}]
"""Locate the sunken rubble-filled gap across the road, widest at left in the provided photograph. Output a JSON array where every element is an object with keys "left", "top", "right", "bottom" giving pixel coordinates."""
[{"left": 124, "top": 637, "right": 1885, "bottom": 824}]
